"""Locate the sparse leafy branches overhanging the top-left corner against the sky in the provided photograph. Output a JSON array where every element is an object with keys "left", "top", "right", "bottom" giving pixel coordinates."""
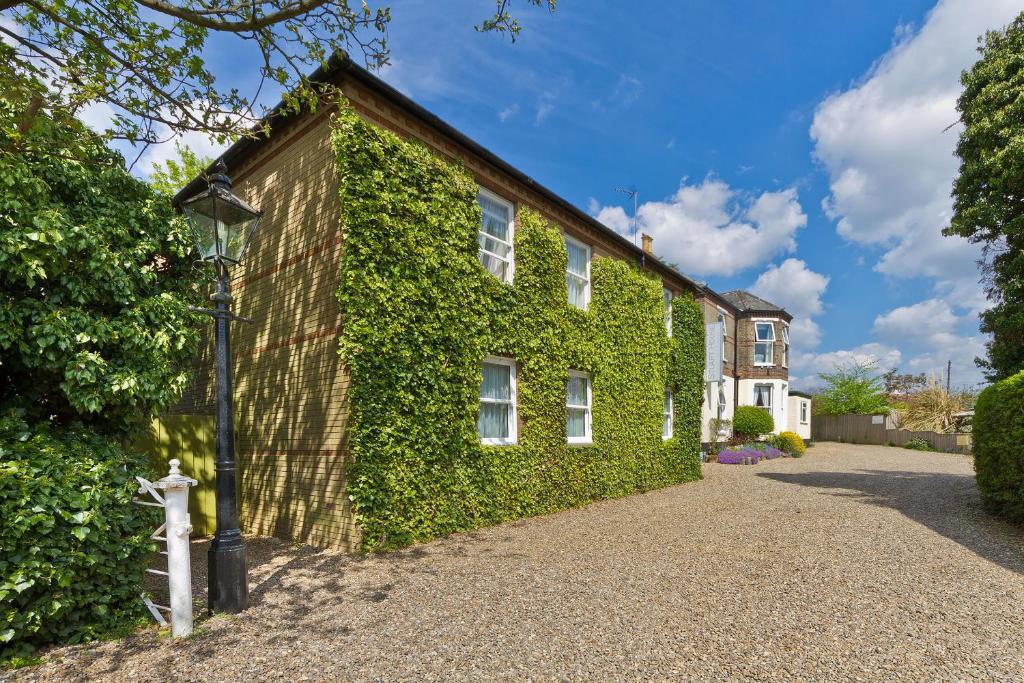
[{"left": 0, "top": 0, "right": 555, "bottom": 154}]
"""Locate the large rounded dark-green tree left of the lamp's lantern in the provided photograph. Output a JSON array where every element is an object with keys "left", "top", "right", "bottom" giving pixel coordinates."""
[{"left": 0, "top": 90, "right": 203, "bottom": 437}]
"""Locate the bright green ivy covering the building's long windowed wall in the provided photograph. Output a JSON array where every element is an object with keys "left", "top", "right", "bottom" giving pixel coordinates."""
[{"left": 333, "top": 101, "right": 703, "bottom": 549}]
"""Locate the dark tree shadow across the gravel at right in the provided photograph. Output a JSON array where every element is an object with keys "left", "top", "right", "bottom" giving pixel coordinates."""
[{"left": 757, "top": 470, "right": 1024, "bottom": 573}]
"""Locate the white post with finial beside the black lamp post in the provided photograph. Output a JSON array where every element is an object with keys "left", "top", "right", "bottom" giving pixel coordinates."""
[{"left": 155, "top": 460, "right": 198, "bottom": 638}]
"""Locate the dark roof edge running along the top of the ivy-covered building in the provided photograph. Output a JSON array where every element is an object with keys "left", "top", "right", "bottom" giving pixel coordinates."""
[{"left": 173, "top": 51, "right": 717, "bottom": 296}]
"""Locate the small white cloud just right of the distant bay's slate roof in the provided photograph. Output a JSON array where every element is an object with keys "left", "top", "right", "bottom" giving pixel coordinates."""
[{"left": 751, "top": 258, "right": 829, "bottom": 349}]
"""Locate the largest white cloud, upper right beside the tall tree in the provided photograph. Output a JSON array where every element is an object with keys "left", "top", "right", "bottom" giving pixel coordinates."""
[{"left": 811, "top": 0, "right": 1020, "bottom": 310}]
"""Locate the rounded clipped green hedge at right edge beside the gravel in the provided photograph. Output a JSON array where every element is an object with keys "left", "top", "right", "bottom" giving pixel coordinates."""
[{"left": 974, "top": 372, "right": 1024, "bottom": 521}]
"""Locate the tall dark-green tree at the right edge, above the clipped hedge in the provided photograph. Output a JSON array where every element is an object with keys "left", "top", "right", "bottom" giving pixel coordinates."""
[{"left": 944, "top": 14, "right": 1024, "bottom": 381}]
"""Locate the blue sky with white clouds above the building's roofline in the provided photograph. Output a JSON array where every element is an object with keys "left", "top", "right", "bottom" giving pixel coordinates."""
[{"left": 138, "top": 0, "right": 1020, "bottom": 388}]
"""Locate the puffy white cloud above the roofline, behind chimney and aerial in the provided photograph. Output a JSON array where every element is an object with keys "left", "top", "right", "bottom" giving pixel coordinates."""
[{"left": 591, "top": 177, "right": 807, "bottom": 275}]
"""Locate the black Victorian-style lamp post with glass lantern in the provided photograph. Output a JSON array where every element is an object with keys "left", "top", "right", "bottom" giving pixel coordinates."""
[{"left": 181, "top": 161, "right": 263, "bottom": 614}]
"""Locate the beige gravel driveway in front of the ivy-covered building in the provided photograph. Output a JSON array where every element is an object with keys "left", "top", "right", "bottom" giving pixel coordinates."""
[{"left": 8, "top": 443, "right": 1024, "bottom": 681}]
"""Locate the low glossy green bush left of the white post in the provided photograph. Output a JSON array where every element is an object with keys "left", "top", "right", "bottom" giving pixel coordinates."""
[{"left": 0, "top": 417, "right": 156, "bottom": 661}]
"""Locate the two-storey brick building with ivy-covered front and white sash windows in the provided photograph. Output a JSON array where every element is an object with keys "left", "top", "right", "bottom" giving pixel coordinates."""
[{"left": 175, "top": 57, "right": 798, "bottom": 549}]
